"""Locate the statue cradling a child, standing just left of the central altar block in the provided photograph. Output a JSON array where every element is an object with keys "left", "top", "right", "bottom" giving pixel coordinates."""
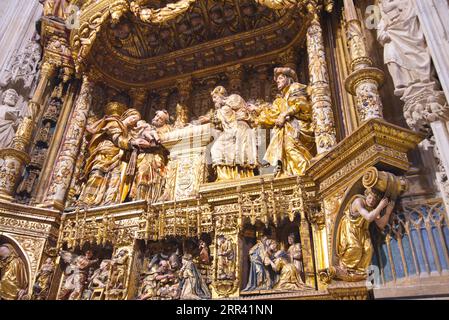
[{"left": 130, "top": 110, "right": 171, "bottom": 202}]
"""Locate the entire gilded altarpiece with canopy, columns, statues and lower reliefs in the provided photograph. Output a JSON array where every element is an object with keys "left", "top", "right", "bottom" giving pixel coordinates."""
[{"left": 0, "top": 0, "right": 449, "bottom": 300}]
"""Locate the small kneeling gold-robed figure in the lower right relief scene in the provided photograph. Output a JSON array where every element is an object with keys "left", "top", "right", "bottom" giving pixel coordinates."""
[{"left": 269, "top": 250, "right": 311, "bottom": 291}]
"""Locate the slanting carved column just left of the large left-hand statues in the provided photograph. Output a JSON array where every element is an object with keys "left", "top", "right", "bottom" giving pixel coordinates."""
[{"left": 44, "top": 75, "right": 93, "bottom": 210}]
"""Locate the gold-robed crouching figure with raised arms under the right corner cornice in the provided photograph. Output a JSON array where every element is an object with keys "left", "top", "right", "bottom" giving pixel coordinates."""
[{"left": 335, "top": 189, "right": 394, "bottom": 281}]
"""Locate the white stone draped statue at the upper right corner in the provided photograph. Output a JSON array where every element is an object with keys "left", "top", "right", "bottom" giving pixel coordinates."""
[{"left": 377, "top": 0, "right": 432, "bottom": 96}]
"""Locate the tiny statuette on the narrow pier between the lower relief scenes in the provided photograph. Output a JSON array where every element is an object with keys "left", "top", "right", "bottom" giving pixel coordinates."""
[{"left": 217, "top": 235, "right": 235, "bottom": 280}]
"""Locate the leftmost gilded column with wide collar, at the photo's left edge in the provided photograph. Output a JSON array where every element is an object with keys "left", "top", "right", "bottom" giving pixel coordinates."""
[{"left": 0, "top": 61, "right": 56, "bottom": 200}]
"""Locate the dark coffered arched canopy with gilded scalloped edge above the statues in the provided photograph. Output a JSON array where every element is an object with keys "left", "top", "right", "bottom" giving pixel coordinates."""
[{"left": 67, "top": 0, "right": 329, "bottom": 88}]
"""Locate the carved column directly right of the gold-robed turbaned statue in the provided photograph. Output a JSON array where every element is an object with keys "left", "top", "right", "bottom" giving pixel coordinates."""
[{"left": 307, "top": 10, "right": 337, "bottom": 155}]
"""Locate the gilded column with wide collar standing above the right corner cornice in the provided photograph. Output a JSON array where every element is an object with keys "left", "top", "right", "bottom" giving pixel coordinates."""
[{"left": 344, "top": 0, "right": 384, "bottom": 123}]
